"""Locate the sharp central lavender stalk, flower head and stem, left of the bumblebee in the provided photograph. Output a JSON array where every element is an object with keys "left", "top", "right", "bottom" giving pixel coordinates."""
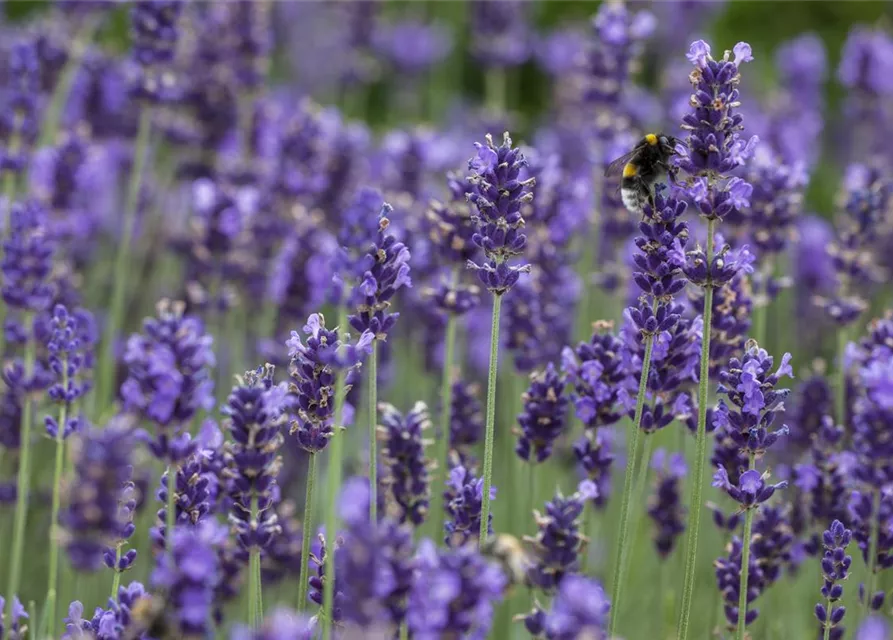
[{"left": 468, "top": 132, "right": 536, "bottom": 542}]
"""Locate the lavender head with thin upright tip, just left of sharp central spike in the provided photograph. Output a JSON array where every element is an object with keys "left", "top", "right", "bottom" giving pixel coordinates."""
[{"left": 349, "top": 204, "right": 412, "bottom": 341}]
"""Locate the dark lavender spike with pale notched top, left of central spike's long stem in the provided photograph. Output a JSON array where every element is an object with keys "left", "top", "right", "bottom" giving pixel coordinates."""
[{"left": 378, "top": 402, "right": 431, "bottom": 526}]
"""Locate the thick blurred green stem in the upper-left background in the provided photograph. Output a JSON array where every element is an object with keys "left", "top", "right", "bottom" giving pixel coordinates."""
[{"left": 96, "top": 106, "right": 152, "bottom": 410}]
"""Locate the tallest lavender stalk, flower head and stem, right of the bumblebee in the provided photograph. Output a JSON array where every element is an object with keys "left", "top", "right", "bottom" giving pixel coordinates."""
[{"left": 677, "top": 40, "right": 757, "bottom": 640}]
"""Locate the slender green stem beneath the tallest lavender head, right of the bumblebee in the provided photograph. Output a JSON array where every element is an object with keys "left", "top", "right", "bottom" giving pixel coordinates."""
[{"left": 677, "top": 220, "right": 716, "bottom": 640}]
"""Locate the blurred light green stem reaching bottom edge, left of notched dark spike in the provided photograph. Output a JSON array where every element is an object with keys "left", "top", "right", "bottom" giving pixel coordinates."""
[{"left": 323, "top": 307, "right": 347, "bottom": 640}]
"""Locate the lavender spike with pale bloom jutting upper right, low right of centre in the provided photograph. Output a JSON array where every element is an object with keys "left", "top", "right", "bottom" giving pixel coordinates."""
[{"left": 527, "top": 490, "right": 595, "bottom": 594}]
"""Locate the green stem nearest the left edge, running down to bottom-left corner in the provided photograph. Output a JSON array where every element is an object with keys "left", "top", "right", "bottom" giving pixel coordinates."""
[{"left": 6, "top": 324, "right": 36, "bottom": 635}]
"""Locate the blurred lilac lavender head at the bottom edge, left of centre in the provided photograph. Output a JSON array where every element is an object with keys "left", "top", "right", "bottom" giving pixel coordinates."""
[{"left": 152, "top": 521, "right": 226, "bottom": 637}]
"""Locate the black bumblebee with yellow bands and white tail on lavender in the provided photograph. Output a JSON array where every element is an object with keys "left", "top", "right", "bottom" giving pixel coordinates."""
[{"left": 605, "top": 133, "right": 676, "bottom": 213}]
